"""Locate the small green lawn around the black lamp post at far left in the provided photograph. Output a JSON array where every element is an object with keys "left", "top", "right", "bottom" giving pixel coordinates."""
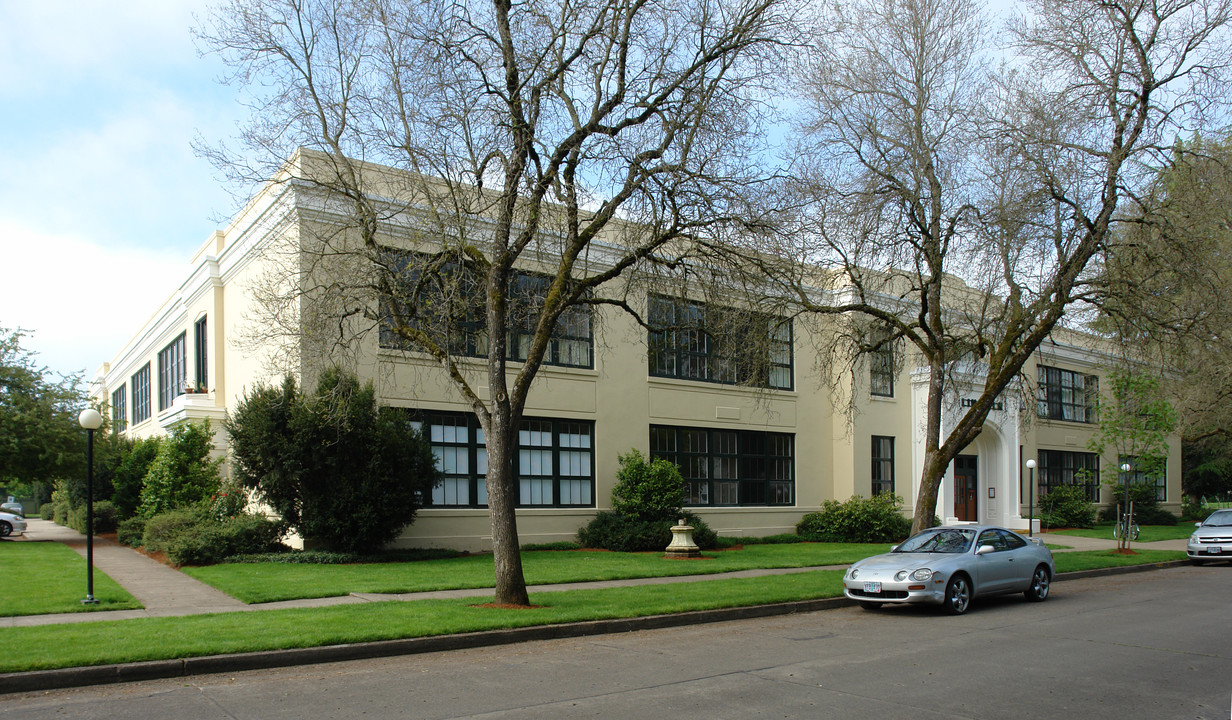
[{"left": 0, "top": 541, "right": 142, "bottom": 618}]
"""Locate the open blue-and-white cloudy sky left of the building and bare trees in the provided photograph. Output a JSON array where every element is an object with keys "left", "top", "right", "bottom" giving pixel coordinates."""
[{"left": 0, "top": 0, "right": 243, "bottom": 377}]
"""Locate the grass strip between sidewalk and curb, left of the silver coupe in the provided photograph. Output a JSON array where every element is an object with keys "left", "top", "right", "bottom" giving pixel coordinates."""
[{"left": 0, "top": 571, "right": 843, "bottom": 672}]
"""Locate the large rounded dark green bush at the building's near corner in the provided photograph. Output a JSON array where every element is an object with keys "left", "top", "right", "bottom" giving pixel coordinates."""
[{"left": 224, "top": 370, "right": 440, "bottom": 552}]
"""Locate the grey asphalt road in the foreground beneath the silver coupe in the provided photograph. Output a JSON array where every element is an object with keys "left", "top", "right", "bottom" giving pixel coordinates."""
[{"left": 0, "top": 565, "right": 1232, "bottom": 720}]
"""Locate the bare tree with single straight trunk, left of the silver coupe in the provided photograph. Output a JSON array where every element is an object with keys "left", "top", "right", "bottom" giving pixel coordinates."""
[{"left": 201, "top": 0, "right": 797, "bottom": 604}]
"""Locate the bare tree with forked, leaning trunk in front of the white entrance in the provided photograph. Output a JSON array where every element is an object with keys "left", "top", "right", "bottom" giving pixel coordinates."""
[{"left": 763, "top": 0, "right": 1228, "bottom": 530}]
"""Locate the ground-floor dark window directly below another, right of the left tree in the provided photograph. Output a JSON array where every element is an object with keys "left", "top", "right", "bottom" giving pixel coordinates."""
[{"left": 650, "top": 425, "right": 796, "bottom": 505}]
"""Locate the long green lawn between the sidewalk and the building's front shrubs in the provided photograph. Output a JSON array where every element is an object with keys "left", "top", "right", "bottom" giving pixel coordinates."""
[{"left": 182, "top": 542, "right": 890, "bottom": 603}]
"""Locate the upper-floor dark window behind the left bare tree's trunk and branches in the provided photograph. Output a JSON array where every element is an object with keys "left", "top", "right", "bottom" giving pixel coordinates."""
[{"left": 381, "top": 249, "right": 595, "bottom": 367}]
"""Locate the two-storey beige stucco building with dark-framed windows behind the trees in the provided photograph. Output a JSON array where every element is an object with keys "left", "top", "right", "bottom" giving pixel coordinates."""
[{"left": 92, "top": 154, "right": 1180, "bottom": 550}]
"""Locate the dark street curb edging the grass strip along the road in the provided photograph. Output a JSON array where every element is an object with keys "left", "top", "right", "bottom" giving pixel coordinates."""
[{"left": 0, "top": 560, "right": 1189, "bottom": 694}]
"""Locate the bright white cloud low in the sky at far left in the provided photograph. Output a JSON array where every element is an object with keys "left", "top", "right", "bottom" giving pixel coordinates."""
[{"left": 0, "top": 218, "right": 188, "bottom": 378}]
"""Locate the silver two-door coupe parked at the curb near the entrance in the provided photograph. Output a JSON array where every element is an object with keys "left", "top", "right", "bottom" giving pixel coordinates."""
[{"left": 843, "top": 525, "right": 1056, "bottom": 615}]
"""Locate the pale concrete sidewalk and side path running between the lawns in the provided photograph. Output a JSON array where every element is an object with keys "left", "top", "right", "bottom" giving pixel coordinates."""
[{"left": 0, "top": 518, "right": 1185, "bottom": 628}]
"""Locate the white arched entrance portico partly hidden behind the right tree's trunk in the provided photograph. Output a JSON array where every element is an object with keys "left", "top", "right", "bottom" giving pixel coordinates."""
[{"left": 912, "top": 367, "right": 1027, "bottom": 531}]
